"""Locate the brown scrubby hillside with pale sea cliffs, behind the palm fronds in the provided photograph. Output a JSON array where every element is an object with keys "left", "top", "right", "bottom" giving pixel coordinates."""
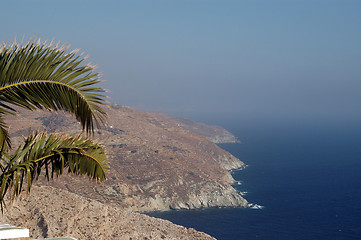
[{"left": 7, "top": 106, "right": 247, "bottom": 211}]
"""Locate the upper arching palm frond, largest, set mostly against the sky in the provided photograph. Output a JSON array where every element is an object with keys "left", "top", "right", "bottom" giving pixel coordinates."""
[{"left": 0, "top": 39, "right": 105, "bottom": 132}]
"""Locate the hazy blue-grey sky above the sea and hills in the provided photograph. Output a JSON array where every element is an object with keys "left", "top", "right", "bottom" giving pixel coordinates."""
[{"left": 0, "top": 0, "right": 361, "bottom": 118}]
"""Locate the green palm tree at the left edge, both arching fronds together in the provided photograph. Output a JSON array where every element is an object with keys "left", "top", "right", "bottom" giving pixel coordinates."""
[{"left": 0, "top": 39, "right": 108, "bottom": 211}]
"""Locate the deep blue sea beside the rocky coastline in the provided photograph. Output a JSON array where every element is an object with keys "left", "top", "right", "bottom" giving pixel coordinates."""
[{"left": 149, "top": 116, "right": 361, "bottom": 240}]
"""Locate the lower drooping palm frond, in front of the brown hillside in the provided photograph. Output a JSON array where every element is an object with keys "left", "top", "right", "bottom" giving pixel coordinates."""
[{"left": 0, "top": 132, "right": 109, "bottom": 210}]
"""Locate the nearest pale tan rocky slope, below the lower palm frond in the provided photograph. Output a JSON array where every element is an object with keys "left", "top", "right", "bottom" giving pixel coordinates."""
[{"left": 0, "top": 186, "right": 214, "bottom": 240}]
